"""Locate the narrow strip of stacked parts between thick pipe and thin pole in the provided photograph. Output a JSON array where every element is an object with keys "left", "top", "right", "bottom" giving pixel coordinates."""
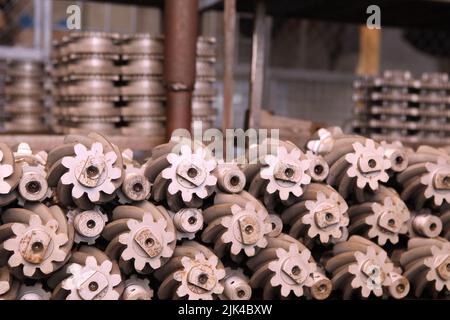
[{"left": 192, "top": 37, "right": 216, "bottom": 129}]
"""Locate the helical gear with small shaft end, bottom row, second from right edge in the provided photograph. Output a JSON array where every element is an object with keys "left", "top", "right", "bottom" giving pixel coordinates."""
[{"left": 325, "top": 236, "right": 409, "bottom": 300}]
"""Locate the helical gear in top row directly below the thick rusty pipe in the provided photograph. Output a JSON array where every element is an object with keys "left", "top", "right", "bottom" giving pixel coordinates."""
[{"left": 145, "top": 139, "right": 217, "bottom": 211}]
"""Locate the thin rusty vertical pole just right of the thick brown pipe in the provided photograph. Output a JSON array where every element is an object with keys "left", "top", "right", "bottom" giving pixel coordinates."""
[{"left": 222, "top": 0, "right": 236, "bottom": 131}]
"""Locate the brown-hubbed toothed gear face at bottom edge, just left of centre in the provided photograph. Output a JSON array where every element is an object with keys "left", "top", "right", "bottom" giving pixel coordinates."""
[{"left": 173, "top": 252, "right": 225, "bottom": 300}]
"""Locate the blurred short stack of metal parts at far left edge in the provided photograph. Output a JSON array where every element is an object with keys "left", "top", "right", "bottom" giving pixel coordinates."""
[{"left": 3, "top": 61, "right": 47, "bottom": 133}]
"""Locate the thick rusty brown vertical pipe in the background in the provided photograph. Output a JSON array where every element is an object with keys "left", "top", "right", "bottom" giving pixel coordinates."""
[{"left": 164, "top": 0, "right": 198, "bottom": 137}]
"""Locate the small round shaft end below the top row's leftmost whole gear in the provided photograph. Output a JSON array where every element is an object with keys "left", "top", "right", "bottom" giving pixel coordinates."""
[{"left": 67, "top": 206, "right": 108, "bottom": 245}]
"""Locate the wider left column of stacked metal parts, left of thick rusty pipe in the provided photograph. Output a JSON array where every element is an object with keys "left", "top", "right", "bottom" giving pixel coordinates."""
[{"left": 53, "top": 32, "right": 120, "bottom": 134}]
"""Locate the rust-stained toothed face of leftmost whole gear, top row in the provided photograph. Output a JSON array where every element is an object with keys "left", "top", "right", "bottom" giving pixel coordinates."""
[{"left": 61, "top": 142, "right": 122, "bottom": 202}]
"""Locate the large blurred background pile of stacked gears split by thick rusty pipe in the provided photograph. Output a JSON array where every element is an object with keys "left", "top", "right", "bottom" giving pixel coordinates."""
[{"left": 52, "top": 32, "right": 216, "bottom": 136}]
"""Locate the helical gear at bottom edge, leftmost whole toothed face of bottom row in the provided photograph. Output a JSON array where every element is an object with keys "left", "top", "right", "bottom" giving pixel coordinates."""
[{"left": 47, "top": 246, "right": 124, "bottom": 300}]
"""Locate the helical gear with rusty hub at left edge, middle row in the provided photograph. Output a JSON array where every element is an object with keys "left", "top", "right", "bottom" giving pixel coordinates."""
[{"left": 0, "top": 203, "right": 73, "bottom": 279}]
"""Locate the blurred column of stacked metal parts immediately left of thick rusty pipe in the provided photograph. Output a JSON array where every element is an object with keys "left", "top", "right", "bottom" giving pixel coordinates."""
[{"left": 120, "top": 34, "right": 165, "bottom": 136}]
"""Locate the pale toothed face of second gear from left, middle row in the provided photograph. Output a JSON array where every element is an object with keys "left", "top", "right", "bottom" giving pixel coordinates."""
[{"left": 119, "top": 213, "right": 175, "bottom": 271}]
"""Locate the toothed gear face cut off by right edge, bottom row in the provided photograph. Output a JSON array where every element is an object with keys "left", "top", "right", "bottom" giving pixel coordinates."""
[{"left": 424, "top": 243, "right": 450, "bottom": 291}]
